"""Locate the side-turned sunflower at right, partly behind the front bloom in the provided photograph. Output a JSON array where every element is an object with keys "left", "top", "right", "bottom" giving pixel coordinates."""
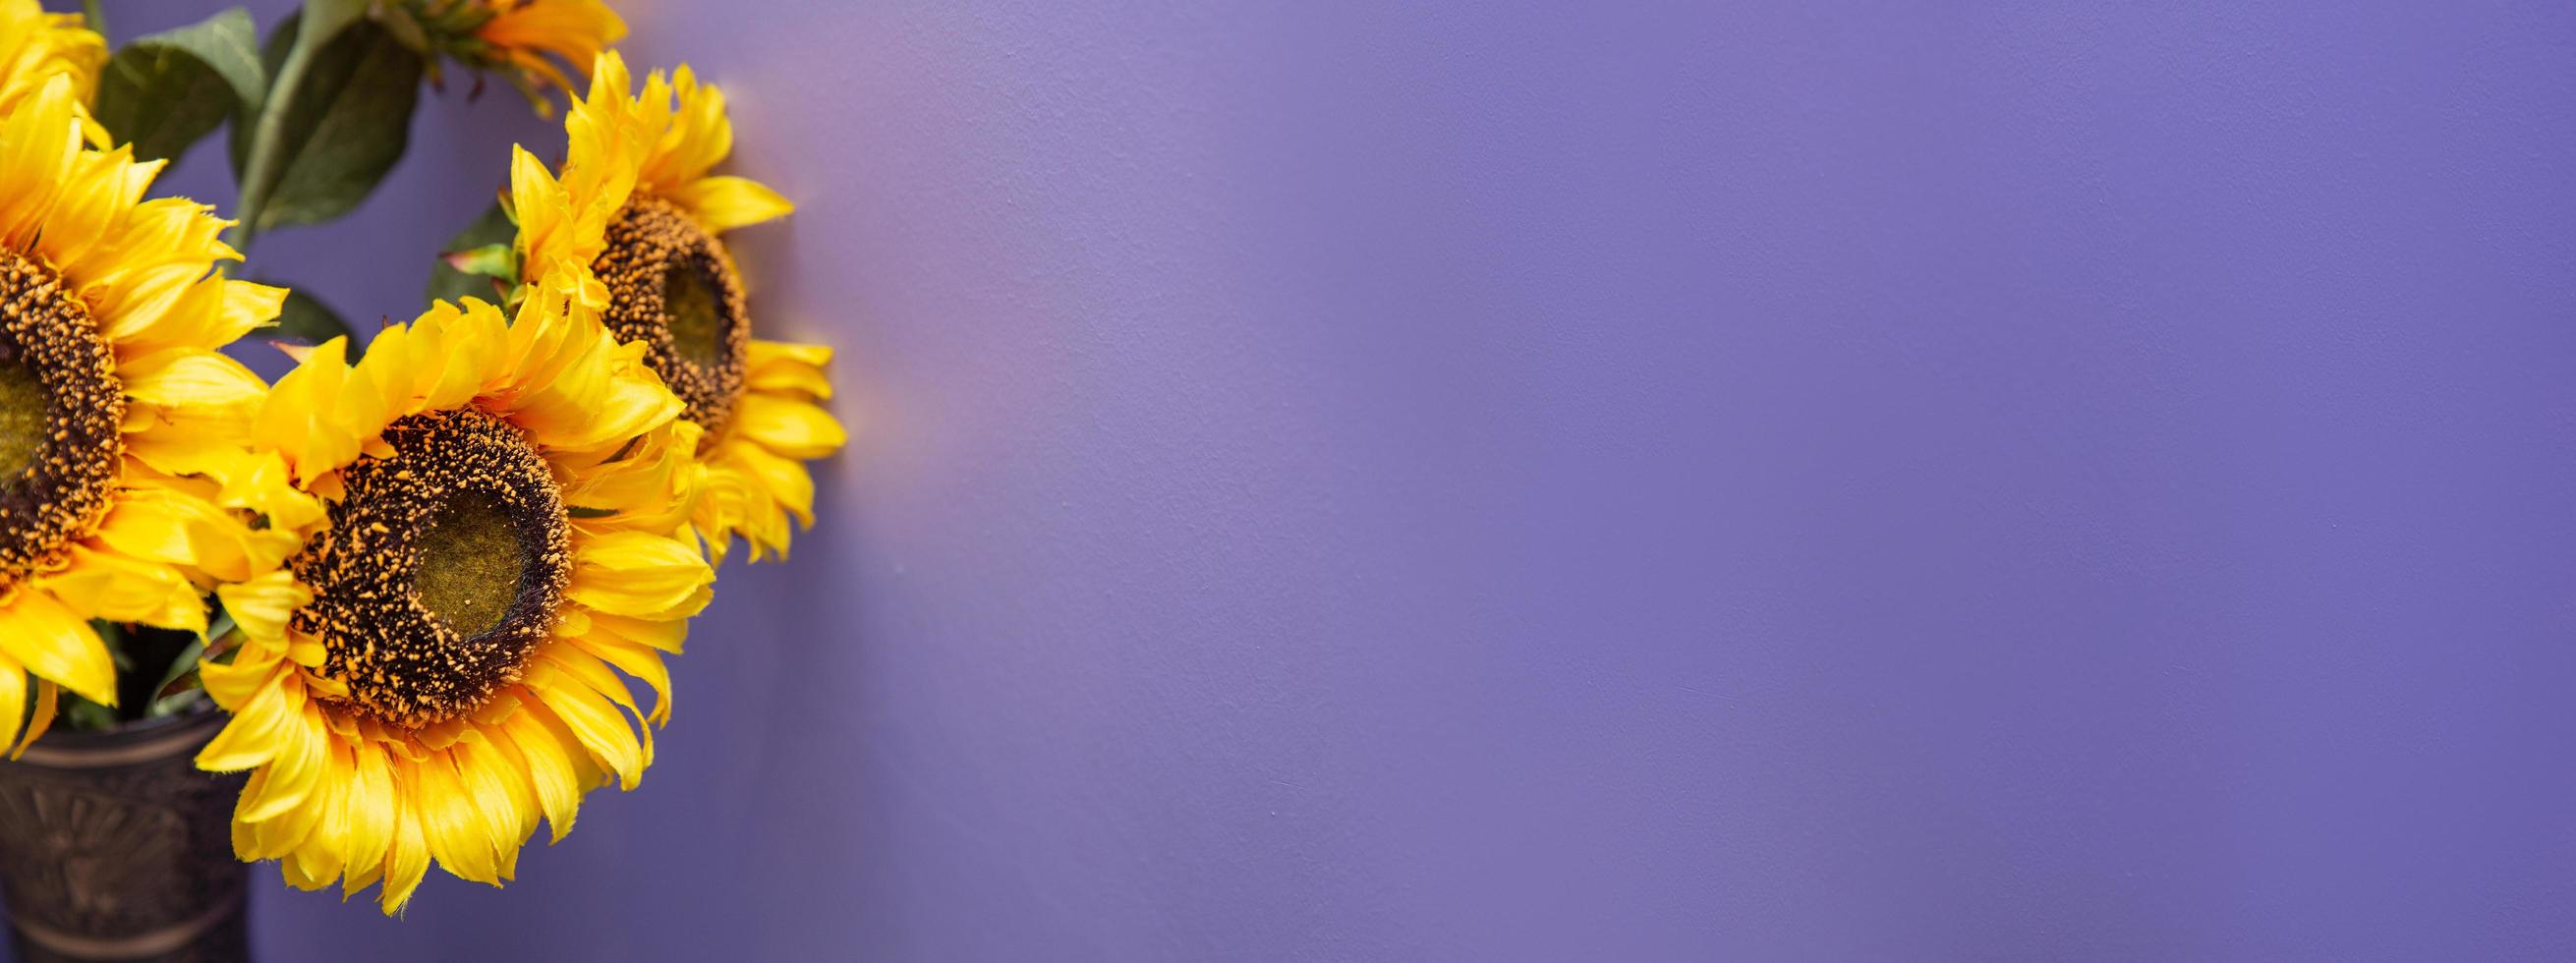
[{"left": 510, "top": 54, "right": 845, "bottom": 561}]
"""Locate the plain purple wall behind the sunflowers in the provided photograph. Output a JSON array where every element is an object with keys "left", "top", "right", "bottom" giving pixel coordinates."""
[{"left": 20, "top": 0, "right": 2576, "bottom": 960}]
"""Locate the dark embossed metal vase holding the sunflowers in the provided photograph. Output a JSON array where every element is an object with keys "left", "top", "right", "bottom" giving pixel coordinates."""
[{"left": 0, "top": 713, "right": 250, "bottom": 963}]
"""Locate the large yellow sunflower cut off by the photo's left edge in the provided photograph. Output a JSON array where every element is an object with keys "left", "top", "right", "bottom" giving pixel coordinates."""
[{"left": 0, "top": 75, "right": 286, "bottom": 752}]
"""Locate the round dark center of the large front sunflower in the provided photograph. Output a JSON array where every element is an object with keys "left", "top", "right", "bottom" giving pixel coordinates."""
[{"left": 294, "top": 410, "right": 572, "bottom": 726}]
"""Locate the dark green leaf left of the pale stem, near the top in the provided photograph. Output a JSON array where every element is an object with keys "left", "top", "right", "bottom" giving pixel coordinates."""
[{"left": 98, "top": 8, "right": 268, "bottom": 159}]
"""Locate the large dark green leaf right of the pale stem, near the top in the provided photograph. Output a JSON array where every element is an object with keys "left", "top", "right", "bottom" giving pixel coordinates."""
[{"left": 232, "top": 18, "right": 423, "bottom": 232}]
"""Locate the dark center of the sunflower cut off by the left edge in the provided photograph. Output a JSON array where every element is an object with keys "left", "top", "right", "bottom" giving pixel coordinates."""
[{"left": 0, "top": 253, "right": 126, "bottom": 587}]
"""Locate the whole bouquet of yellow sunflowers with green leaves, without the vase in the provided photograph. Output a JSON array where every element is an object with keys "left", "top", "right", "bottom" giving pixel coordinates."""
[{"left": 0, "top": 0, "right": 842, "bottom": 914}]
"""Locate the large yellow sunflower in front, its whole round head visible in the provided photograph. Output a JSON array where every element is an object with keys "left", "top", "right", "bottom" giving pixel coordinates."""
[{"left": 199, "top": 268, "right": 714, "bottom": 914}]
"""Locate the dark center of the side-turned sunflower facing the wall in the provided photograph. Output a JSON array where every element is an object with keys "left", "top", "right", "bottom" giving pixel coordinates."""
[{"left": 593, "top": 194, "right": 752, "bottom": 430}]
